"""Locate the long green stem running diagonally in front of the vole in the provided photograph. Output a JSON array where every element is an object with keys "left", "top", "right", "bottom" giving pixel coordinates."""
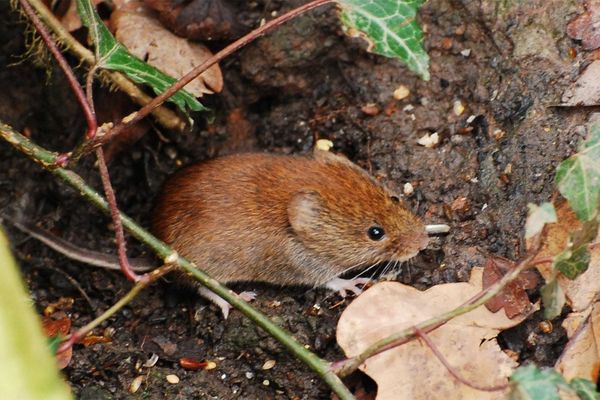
[{"left": 0, "top": 121, "right": 354, "bottom": 400}]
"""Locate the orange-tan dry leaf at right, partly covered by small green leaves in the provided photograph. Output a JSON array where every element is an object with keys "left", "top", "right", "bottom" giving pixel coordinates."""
[{"left": 534, "top": 202, "right": 600, "bottom": 312}]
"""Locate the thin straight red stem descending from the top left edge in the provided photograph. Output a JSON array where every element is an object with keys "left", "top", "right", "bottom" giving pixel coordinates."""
[{"left": 19, "top": 0, "right": 98, "bottom": 145}]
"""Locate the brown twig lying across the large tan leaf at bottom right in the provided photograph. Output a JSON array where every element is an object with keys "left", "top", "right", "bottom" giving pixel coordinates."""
[{"left": 331, "top": 233, "right": 546, "bottom": 377}]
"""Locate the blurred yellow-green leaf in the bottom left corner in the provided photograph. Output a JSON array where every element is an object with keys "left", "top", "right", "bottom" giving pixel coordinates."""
[{"left": 0, "top": 229, "right": 72, "bottom": 400}]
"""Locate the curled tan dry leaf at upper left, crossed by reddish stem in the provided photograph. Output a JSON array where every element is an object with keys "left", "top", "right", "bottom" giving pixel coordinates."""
[{"left": 110, "top": 1, "right": 223, "bottom": 97}]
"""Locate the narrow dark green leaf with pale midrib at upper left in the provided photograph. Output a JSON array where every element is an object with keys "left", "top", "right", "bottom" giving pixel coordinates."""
[{"left": 77, "top": 0, "right": 207, "bottom": 112}]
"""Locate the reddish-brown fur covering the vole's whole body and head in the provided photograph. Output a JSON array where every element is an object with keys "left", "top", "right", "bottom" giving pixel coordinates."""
[{"left": 153, "top": 150, "right": 427, "bottom": 286}]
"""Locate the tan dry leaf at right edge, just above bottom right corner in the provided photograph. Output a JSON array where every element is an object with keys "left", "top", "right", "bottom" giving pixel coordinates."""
[{"left": 555, "top": 302, "right": 600, "bottom": 382}]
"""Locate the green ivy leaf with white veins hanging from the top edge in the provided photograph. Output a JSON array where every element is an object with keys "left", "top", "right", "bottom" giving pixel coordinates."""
[{"left": 337, "top": 0, "right": 429, "bottom": 81}]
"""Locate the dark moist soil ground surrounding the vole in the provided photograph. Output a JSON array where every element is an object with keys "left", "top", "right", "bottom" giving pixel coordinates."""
[{"left": 0, "top": 0, "right": 588, "bottom": 399}]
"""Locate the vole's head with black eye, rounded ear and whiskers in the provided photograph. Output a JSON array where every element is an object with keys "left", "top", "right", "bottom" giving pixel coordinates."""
[{"left": 288, "top": 151, "right": 428, "bottom": 273}]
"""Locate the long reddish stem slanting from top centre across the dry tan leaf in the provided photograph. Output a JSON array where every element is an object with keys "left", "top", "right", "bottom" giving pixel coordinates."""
[{"left": 86, "top": 0, "right": 335, "bottom": 150}]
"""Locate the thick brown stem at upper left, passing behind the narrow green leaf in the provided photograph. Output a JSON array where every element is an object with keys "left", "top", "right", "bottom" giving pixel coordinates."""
[{"left": 23, "top": 0, "right": 187, "bottom": 131}]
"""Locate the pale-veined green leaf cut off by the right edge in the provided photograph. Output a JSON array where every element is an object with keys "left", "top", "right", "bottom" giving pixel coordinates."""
[{"left": 556, "top": 125, "right": 600, "bottom": 221}]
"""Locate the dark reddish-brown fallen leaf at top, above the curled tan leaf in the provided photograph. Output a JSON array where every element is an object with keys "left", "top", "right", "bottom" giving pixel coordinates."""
[{"left": 144, "top": 0, "right": 245, "bottom": 41}]
